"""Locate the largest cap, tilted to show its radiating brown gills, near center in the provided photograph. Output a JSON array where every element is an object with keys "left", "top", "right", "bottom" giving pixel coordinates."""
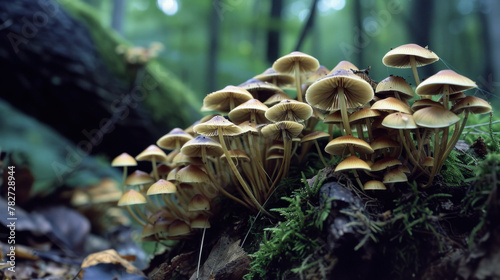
[{"left": 306, "top": 69, "right": 373, "bottom": 111}]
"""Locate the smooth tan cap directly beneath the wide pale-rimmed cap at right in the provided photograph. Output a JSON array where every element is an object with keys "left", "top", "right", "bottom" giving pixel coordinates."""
[{"left": 413, "top": 106, "right": 460, "bottom": 128}]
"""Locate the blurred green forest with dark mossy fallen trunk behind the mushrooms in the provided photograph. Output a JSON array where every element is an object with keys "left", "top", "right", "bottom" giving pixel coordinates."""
[{"left": 0, "top": 0, "right": 500, "bottom": 197}]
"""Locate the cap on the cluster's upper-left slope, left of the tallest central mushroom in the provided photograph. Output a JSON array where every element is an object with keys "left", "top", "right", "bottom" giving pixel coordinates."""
[{"left": 203, "top": 85, "right": 253, "bottom": 113}]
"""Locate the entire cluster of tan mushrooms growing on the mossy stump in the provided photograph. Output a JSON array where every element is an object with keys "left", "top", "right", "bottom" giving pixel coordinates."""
[{"left": 112, "top": 44, "right": 491, "bottom": 240}]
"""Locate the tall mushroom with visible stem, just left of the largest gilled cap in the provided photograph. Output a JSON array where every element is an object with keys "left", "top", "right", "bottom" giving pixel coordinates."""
[{"left": 273, "top": 51, "right": 319, "bottom": 102}]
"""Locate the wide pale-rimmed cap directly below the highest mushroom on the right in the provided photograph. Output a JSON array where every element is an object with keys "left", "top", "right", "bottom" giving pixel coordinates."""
[{"left": 415, "top": 69, "right": 477, "bottom": 95}]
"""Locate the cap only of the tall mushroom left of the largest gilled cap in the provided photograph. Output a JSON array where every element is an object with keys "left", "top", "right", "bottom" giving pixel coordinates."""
[{"left": 273, "top": 51, "right": 319, "bottom": 73}]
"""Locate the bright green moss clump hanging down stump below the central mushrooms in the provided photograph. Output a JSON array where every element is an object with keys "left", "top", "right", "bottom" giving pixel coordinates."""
[{"left": 245, "top": 172, "right": 330, "bottom": 279}]
